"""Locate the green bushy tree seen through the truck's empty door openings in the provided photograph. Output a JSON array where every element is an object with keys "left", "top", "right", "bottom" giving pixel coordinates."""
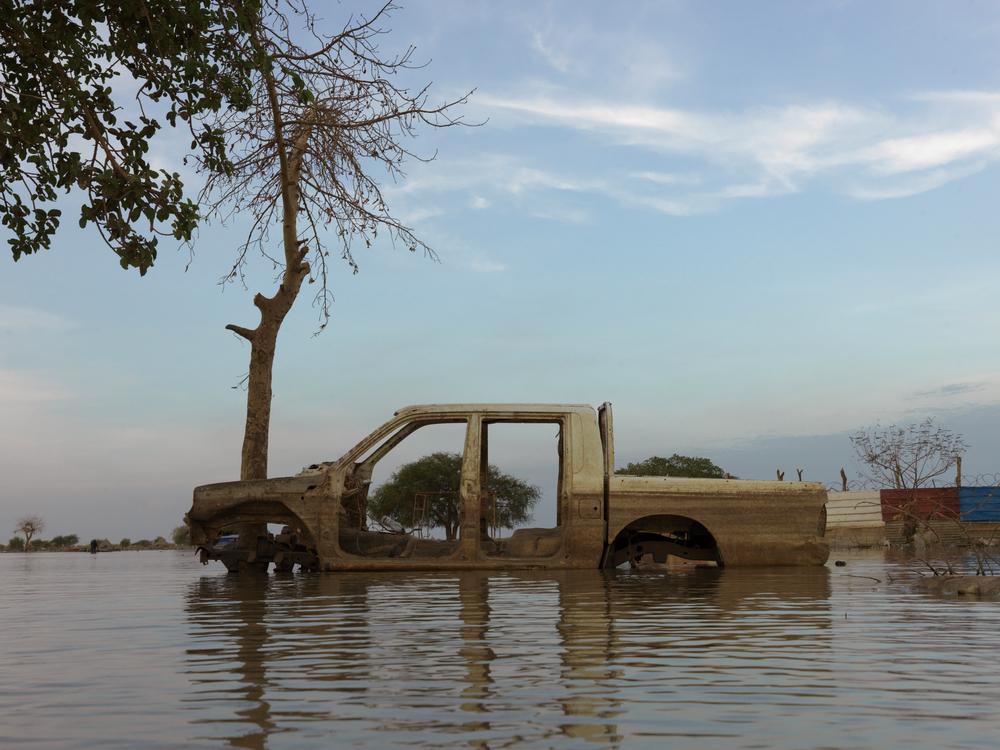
[{"left": 368, "top": 452, "right": 541, "bottom": 539}]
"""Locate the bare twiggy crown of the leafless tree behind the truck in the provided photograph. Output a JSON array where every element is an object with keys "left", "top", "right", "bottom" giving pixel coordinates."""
[{"left": 202, "top": 0, "right": 467, "bottom": 325}]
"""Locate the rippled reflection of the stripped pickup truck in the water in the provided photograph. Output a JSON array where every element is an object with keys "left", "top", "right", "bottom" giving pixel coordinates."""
[{"left": 185, "top": 568, "right": 831, "bottom": 748}]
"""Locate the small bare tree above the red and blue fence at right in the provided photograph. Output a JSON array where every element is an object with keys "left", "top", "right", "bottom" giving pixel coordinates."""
[{"left": 851, "top": 418, "right": 969, "bottom": 489}]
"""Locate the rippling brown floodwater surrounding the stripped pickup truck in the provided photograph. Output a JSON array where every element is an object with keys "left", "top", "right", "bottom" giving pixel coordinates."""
[{"left": 0, "top": 552, "right": 1000, "bottom": 750}]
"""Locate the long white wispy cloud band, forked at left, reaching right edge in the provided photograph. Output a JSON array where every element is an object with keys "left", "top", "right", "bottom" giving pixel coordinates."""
[{"left": 386, "top": 87, "right": 1000, "bottom": 224}]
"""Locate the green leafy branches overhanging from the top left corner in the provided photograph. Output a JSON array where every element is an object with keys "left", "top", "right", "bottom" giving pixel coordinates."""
[{"left": 0, "top": 0, "right": 260, "bottom": 273}]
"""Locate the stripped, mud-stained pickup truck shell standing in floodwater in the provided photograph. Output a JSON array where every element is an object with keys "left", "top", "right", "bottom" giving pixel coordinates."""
[{"left": 186, "top": 403, "right": 829, "bottom": 572}]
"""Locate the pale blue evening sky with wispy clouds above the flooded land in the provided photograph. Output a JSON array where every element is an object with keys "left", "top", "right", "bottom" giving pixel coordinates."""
[{"left": 0, "top": 0, "right": 1000, "bottom": 539}]
